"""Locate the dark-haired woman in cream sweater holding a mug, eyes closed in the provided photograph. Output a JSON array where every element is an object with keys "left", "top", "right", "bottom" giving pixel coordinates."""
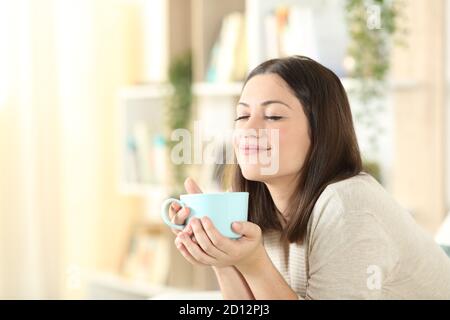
[{"left": 167, "top": 56, "right": 450, "bottom": 299}]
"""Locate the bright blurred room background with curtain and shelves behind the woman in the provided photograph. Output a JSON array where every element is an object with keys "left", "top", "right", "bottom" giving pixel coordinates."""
[{"left": 0, "top": 0, "right": 450, "bottom": 299}]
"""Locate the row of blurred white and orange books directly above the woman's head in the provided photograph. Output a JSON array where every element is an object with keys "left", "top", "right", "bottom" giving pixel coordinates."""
[{"left": 262, "top": 1, "right": 349, "bottom": 77}]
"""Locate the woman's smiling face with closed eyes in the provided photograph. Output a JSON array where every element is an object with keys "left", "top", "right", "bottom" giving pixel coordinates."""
[{"left": 234, "top": 74, "right": 310, "bottom": 183}]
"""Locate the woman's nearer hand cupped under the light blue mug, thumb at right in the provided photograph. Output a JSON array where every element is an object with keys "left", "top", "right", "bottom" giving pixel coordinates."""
[{"left": 175, "top": 217, "right": 265, "bottom": 269}]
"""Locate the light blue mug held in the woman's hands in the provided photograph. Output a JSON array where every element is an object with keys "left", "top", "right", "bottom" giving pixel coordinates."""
[{"left": 161, "top": 192, "right": 248, "bottom": 239}]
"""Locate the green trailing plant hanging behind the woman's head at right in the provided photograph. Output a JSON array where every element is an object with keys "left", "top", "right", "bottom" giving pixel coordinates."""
[{"left": 345, "top": 0, "right": 405, "bottom": 182}]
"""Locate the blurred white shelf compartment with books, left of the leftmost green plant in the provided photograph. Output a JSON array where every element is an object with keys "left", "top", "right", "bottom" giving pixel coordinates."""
[{"left": 117, "top": 83, "right": 173, "bottom": 198}]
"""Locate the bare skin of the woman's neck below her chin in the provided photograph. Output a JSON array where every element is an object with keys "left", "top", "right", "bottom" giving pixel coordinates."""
[{"left": 265, "top": 175, "right": 298, "bottom": 218}]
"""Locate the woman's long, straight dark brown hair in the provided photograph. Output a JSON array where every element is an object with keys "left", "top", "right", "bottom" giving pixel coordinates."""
[{"left": 231, "top": 56, "right": 362, "bottom": 243}]
